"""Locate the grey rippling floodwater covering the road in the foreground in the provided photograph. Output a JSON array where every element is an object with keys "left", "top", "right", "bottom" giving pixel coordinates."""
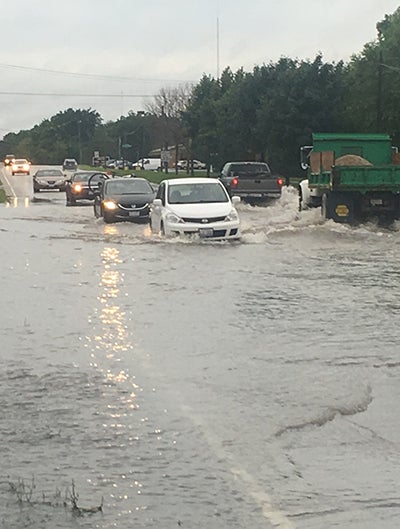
[{"left": 0, "top": 178, "right": 400, "bottom": 529}]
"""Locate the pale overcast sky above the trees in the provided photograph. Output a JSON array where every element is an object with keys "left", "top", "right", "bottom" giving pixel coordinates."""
[{"left": 0, "top": 0, "right": 400, "bottom": 138}]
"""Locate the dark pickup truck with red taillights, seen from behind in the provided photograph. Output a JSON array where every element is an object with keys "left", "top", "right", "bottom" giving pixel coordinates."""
[{"left": 219, "top": 162, "right": 283, "bottom": 200}]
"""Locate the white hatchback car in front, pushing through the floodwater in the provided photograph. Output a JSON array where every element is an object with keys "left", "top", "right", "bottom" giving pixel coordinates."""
[{"left": 150, "top": 178, "right": 240, "bottom": 240}]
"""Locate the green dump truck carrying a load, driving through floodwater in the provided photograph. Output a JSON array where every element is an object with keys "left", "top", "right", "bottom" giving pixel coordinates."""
[{"left": 299, "top": 133, "right": 400, "bottom": 224}]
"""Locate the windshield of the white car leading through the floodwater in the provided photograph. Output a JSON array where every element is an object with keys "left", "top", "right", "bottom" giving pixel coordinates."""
[{"left": 168, "top": 182, "right": 229, "bottom": 204}]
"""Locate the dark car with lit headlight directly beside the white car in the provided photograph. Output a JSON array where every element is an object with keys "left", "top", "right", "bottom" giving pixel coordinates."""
[{"left": 90, "top": 177, "right": 155, "bottom": 223}]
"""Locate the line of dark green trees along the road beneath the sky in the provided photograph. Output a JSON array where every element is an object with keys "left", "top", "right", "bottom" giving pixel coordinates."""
[{"left": 0, "top": 8, "right": 400, "bottom": 177}]
